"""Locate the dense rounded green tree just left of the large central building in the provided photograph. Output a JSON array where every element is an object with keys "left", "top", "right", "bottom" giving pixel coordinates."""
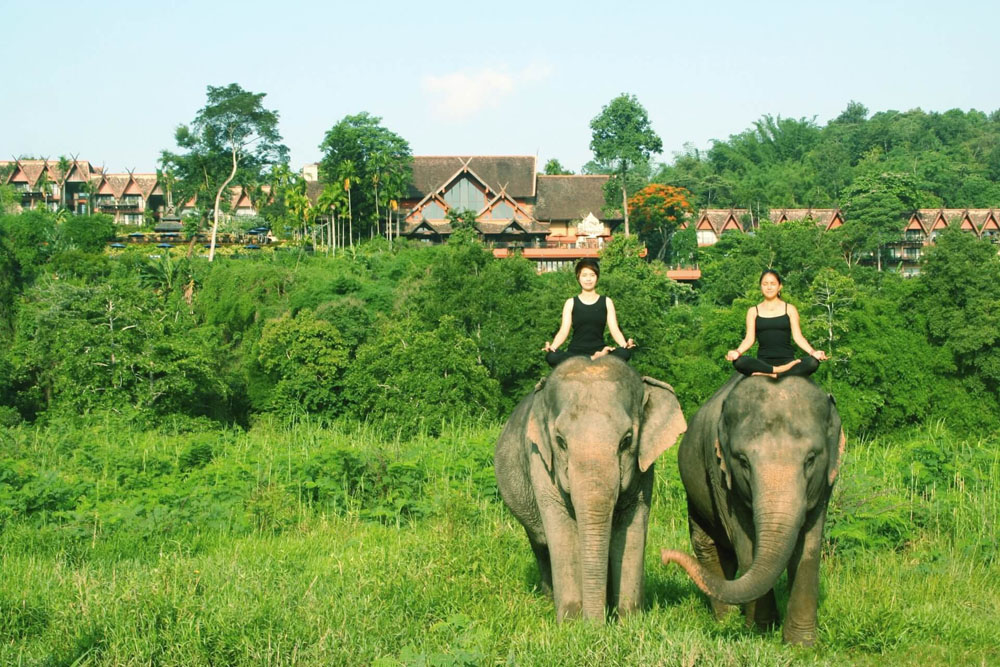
[{"left": 319, "top": 111, "right": 413, "bottom": 243}]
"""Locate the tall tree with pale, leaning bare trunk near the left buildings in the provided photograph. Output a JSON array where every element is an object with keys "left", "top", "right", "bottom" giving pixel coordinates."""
[{"left": 161, "top": 83, "right": 288, "bottom": 261}]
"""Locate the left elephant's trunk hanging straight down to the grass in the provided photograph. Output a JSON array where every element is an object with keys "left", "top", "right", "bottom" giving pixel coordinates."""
[{"left": 572, "top": 463, "right": 618, "bottom": 623}]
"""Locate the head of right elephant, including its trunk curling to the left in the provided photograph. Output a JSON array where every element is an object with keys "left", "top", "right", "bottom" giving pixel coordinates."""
[{"left": 663, "top": 377, "right": 844, "bottom": 604}]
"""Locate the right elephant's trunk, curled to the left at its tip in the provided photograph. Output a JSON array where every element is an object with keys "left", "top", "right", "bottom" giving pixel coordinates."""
[{"left": 660, "top": 485, "right": 805, "bottom": 604}]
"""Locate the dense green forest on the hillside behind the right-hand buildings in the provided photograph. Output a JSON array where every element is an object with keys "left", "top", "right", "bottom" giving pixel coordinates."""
[{"left": 653, "top": 102, "right": 1000, "bottom": 210}]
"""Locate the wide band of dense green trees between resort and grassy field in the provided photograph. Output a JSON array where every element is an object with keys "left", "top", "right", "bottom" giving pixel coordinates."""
[{"left": 0, "top": 211, "right": 1000, "bottom": 433}]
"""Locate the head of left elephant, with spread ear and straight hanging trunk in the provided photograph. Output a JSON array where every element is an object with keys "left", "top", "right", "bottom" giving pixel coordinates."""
[{"left": 526, "top": 356, "right": 687, "bottom": 620}]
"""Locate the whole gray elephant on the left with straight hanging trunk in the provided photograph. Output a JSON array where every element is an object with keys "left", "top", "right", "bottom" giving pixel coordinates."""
[{"left": 494, "top": 356, "right": 686, "bottom": 622}]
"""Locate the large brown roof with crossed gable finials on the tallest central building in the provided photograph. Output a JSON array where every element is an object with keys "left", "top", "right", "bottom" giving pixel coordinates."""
[{"left": 407, "top": 155, "right": 535, "bottom": 199}]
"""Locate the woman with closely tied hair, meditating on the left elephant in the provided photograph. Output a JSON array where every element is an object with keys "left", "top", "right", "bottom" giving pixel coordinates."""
[{"left": 543, "top": 257, "right": 635, "bottom": 366}]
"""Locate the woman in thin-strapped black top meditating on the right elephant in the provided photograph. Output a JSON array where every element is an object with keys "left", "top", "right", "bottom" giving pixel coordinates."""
[{"left": 726, "top": 269, "right": 827, "bottom": 378}]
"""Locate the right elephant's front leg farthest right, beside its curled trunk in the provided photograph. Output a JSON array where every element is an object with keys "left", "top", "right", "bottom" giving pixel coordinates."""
[{"left": 782, "top": 507, "right": 826, "bottom": 646}]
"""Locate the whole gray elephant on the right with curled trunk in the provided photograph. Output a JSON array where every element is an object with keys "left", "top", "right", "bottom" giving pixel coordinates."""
[{"left": 662, "top": 374, "right": 844, "bottom": 645}]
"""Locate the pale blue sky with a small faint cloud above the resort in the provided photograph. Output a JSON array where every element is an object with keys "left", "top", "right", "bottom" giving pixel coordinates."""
[{"left": 0, "top": 0, "right": 1000, "bottom": 172}]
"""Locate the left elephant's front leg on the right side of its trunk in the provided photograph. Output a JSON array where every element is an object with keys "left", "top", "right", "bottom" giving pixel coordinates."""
[{"left": 608, "top": 483, "right": 652, "bottom": 615}]
